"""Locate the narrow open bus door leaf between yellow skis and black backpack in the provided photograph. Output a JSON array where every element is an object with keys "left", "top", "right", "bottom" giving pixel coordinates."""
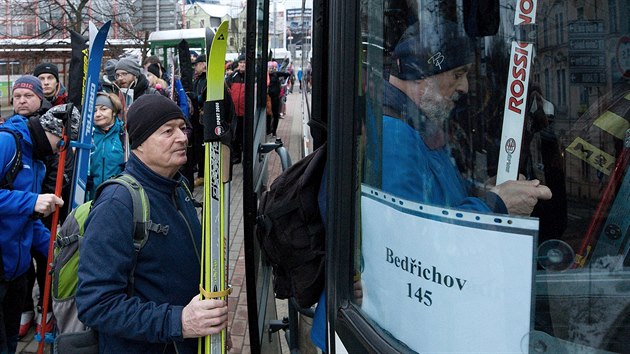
[{"left": 243, "top": 0, "right": 282, "bottom": 353}]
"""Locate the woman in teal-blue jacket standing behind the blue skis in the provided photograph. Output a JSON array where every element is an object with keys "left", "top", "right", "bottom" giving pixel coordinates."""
[{"left": 88, "top": 92, "right": 125, "bottom": 200}]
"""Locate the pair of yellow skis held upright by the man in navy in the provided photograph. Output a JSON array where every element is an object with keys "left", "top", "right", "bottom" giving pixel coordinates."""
[{"left": 198, "top": 21, "right": 231, "bottom": 354}]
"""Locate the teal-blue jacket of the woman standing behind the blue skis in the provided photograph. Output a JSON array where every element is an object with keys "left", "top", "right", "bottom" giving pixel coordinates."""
[{"left": 88, "top": 119, "right": 125, "bottom": 200}]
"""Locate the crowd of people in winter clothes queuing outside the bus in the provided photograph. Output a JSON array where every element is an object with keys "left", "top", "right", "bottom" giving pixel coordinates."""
[{"left": 0, "top": 51, "right": 245, "bottom": 353}]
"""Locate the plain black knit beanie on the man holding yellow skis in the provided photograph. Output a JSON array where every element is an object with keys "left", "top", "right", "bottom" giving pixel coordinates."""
[{"left": 127, "top": 94, "right": 184, "bottom": 149}]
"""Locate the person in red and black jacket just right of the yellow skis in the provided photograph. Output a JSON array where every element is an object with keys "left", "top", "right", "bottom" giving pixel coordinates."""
[{"left": 227, "top": 54, "right": 245, "bottom": 164}]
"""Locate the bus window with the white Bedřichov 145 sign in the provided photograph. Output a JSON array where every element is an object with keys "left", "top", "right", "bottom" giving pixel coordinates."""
[{"left": 340, "top": 0, "right": 630, "bottom": 353}]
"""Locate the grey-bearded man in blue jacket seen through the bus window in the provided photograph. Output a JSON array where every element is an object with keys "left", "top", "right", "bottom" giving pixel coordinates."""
[{"left": 381, "top": 20, "right": 551, "bottom": 215}]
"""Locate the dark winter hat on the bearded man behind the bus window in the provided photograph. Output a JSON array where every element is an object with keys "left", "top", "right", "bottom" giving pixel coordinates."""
[{"left": 391, "top": 22, "right": 473, "bottom": 80}]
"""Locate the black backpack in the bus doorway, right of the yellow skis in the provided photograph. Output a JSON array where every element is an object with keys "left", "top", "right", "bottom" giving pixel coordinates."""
[{"left": 256, "top": 144, "right": 326, "bottom": 308}]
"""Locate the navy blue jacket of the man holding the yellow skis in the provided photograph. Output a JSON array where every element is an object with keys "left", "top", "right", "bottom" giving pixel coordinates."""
[{"left": 76, "top": 154, "right": 201, "bottom": 353}]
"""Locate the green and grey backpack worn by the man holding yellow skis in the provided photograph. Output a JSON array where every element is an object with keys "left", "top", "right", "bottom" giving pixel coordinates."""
[{"left": 51, "top": 174, "right": 161, "bottom": 335}]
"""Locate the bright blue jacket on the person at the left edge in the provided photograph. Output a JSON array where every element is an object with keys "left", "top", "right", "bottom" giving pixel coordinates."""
[{"left": 0, "top": 115, "right": 50, "bottom": 280}]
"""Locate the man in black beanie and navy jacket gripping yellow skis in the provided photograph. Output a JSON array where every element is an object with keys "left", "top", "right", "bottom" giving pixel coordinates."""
[{"left": 76, "top": 95, "right": 229, "bottom": 353}]
